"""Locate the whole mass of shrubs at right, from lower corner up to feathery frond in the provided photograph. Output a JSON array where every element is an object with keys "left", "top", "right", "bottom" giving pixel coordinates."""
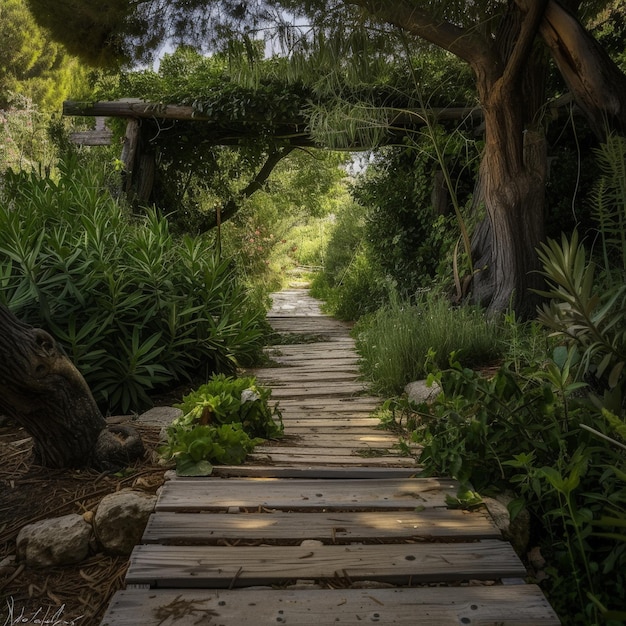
[{"left": 402, "top": 137, "right": 626, "bottom": 625}]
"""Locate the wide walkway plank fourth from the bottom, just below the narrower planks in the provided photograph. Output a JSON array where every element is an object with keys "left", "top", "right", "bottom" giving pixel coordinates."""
[{"left": 156, "top": 476, "right": 458, "bottom": 511}]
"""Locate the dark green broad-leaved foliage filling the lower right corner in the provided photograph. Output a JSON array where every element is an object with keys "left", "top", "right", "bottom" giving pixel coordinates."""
[{"left": 412, "top": 347, "right": 626, "bottom": 625}]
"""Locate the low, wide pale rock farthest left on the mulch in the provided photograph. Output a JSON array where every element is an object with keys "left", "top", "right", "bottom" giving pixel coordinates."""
[{"left": 16, "top": 513, "right": 92, "bottom": 567}]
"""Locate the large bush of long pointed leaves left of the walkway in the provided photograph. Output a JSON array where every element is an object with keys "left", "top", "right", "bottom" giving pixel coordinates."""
[{"left": 0, "top": 156, "right": 265, "bottom": 412}]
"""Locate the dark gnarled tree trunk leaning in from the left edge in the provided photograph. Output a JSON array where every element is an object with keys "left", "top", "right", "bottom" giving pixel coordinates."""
[{"left": 0, "top": 304, "right": 143, "bottom": 470}]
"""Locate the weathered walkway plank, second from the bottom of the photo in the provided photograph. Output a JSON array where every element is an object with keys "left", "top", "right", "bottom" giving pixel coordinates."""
[{"left": 126, "top": 539, "right": 527, "bottom": 588}]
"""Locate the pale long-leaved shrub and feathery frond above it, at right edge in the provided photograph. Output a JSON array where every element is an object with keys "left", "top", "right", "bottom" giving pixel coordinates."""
[{"left": 539, "top": 136, "right": 626, "bottom": 415}]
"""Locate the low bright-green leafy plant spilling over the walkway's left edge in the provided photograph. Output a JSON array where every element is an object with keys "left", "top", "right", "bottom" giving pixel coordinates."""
[{"left": 159, "top": 375, "right": 283, "bottom": 476}]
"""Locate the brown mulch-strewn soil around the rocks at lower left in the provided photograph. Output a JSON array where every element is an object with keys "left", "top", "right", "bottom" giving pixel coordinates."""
[{"left": 0, "top": 414, "right": 167, "bottom": 626}]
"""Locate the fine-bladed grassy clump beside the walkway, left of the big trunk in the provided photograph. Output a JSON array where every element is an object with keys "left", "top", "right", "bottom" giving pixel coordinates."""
[{"left": 354, "top": 295, "right": 505, "bottom": 395}]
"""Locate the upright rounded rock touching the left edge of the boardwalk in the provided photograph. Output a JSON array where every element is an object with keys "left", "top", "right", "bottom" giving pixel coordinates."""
[{"left": 93, "top": 489, "right": 157, "bottom": 556}]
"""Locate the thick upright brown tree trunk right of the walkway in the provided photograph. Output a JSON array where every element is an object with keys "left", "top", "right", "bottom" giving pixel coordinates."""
[{"left": 472, "top": 2, "right": 547, "bottom": 318}]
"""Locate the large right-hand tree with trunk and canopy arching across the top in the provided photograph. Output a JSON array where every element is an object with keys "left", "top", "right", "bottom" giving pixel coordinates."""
[{"left": 30, "top": 0, "right": 626, "bottom": 314}]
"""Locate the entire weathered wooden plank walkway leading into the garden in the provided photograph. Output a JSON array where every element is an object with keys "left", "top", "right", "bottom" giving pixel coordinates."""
[{"left": 102, "top": 290, "right": 559, "bottom": 626}]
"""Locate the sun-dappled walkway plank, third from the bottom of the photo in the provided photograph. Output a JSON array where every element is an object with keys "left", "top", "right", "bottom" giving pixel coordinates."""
[{"left": 142, "top": 509, "right": 501, "bottom": 545}]
